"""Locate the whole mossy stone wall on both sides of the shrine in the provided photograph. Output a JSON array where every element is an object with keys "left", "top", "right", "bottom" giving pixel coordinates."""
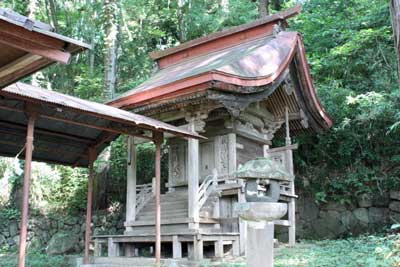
[{"left": 0, "top": 191, "right": 400, "bottom": 254}]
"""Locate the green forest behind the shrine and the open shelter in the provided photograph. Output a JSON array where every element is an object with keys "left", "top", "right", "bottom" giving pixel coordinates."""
[{"left": 0, "top": 0, "right": 400, "bottom": 217}]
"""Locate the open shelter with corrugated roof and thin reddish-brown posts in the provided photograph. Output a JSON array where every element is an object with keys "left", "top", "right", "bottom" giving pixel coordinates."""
[{"left": 0, "top": 83, "right": 201, "bottom": 267}]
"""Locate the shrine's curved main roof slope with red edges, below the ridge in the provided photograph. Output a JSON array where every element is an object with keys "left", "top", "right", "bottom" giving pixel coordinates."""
[{"left": 109, "top": 31, "right": 332, "bottom": 128}]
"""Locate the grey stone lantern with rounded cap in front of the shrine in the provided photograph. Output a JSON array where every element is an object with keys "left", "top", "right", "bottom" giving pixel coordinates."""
[{"left": 236, "top": 158, "right": 292, "bottom": 267}]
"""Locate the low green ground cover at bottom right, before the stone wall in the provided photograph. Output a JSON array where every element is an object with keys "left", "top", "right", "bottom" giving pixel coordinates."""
[{"left": 275, "top": 235, "right": 400, "bottom": 267}]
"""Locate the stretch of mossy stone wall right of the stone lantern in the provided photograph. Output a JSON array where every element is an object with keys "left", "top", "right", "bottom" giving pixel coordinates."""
[{"left": 276, "top": 191, "right": 400, "bottom": 241}]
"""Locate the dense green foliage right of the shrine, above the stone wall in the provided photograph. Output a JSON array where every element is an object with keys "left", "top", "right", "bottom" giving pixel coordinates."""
[{"left": 292, "top": 0, "right": 400, "bottom": 202}]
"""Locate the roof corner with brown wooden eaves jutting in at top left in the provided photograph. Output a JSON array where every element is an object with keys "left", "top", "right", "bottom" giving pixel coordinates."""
[{"left": 0, "top": 8, "right": 90, "bottom": 90}]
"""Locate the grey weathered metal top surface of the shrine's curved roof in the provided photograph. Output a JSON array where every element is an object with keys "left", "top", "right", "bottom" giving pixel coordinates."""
[{"left": 111, "top": 32, "right": 297, "bottom": 100}]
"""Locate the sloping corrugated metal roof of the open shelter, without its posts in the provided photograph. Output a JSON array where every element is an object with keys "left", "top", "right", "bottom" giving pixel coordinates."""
[{"left": 0, "top": 83, "right": 201, "bottom": 167}]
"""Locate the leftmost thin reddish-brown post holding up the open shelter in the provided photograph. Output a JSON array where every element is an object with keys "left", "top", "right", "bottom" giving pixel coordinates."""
[{"left": 18, "top": 114, "right": 36, "bottom": 267}]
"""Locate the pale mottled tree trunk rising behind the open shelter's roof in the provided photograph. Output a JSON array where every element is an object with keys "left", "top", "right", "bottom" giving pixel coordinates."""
[{"left": 103, "top": 0, "right": 119, "bottom": 99}]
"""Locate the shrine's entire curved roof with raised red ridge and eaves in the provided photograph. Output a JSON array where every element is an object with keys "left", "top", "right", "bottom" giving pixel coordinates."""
[{"left": 108, "top": 7, "right": 332, "bottom": 132}]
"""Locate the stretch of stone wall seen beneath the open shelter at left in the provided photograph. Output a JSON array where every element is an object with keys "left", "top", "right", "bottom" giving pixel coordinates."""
[{"left": 0, "top": 211, "right": 124, "bottom": 255}]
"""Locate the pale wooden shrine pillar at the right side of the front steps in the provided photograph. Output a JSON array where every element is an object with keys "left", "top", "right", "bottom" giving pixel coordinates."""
[{"left": 188, "top": 118, "right": 200, "bottom": 229}]
